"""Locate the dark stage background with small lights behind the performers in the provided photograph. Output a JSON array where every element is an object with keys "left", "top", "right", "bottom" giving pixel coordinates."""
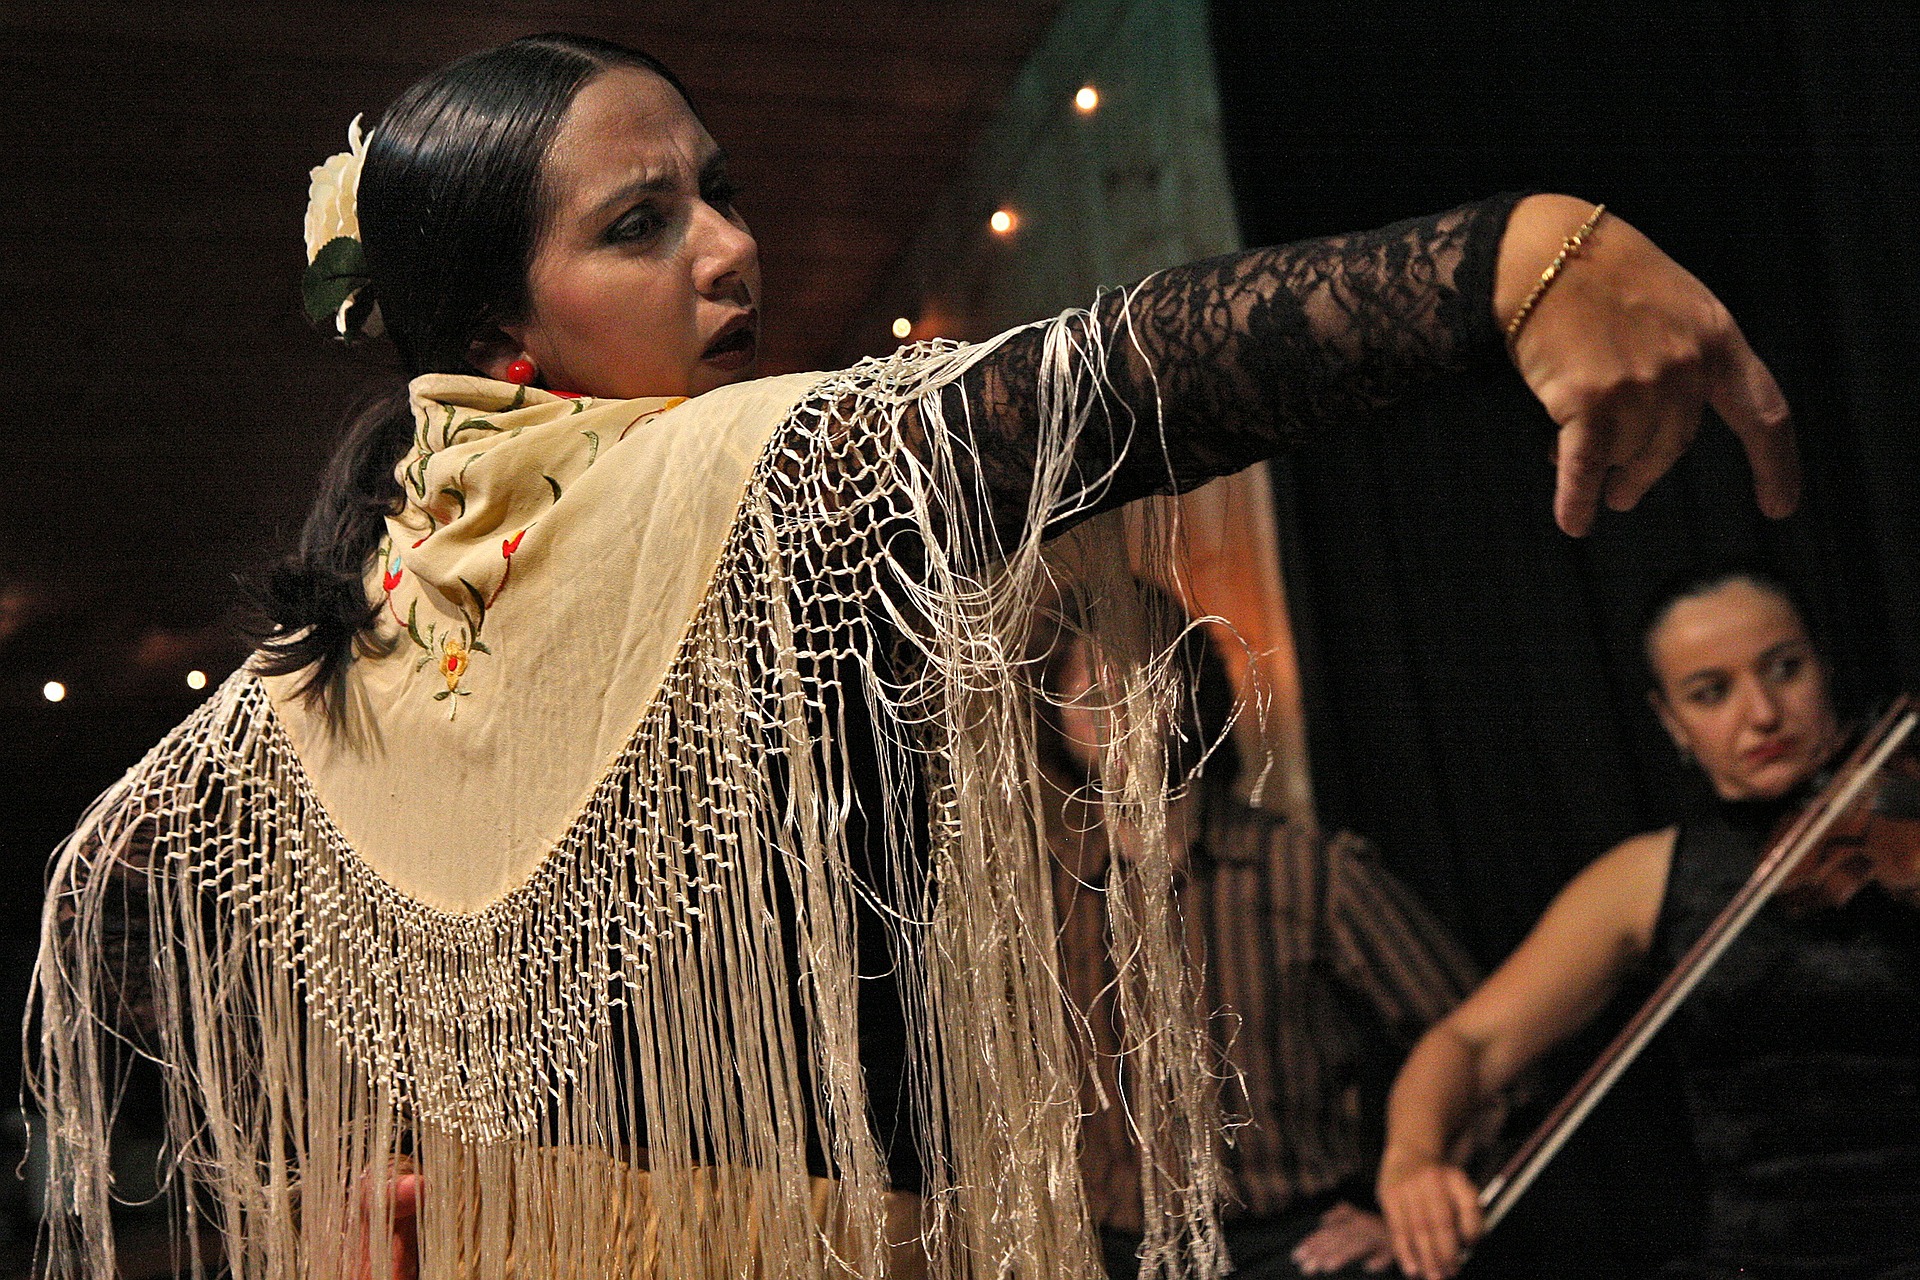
[{"left": 0, "top": 0, "right": 1920, "bottom": 1276}]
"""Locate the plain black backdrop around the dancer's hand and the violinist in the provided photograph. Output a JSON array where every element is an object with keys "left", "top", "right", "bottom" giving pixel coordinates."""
[{"left": 1213, "top": 0, "right": 1920, "bottom": 1276}]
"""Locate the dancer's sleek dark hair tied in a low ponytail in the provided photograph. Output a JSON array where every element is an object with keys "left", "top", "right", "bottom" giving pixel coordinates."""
[{"left": 253, "top": 35, "right": 693, "bottom": 708}]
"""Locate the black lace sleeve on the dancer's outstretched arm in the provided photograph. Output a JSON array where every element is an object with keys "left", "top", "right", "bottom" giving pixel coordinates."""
[{"left": 948, "top": 196, "right": 1521, "bottom": 537}]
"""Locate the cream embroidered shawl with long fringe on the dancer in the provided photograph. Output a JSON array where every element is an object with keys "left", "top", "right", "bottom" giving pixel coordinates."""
[{"left": 35, "top": 313, "right": 1223, "bottom": 1280}]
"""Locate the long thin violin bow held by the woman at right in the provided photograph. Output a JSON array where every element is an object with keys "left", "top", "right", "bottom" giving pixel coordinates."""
[{"left": 1480, "top": 695, "right": 1920, "bottom": 1230}]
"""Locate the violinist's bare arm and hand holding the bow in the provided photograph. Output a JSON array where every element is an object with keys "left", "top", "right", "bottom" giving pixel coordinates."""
[{"left": 1379, "top": 829, "right": 1674, "bottom": 1280}]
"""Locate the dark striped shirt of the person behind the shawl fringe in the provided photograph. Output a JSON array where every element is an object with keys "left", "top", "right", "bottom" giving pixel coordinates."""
[{"left": 1050, "top": 789, "right": 1478, "bottom": 1230}]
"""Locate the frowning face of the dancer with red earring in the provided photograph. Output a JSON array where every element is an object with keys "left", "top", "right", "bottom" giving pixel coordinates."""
[{"left": 486, "top": 67, "right": 760, "bottom": 397}]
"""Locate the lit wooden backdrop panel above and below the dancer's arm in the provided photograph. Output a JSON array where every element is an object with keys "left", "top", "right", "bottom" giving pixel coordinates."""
[{"left": 843, "top": 0, "right": 1313, "bottom": 821}]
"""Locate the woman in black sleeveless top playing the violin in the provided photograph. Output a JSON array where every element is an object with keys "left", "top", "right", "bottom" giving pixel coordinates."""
[{"left": 1379, "top": 568, "right": 1920, "bottom": 1280}]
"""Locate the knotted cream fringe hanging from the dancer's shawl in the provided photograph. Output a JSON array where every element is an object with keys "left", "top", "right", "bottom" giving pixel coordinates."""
[{"left": 33, "top": 295, "right": 1223, "bottom": 1280}]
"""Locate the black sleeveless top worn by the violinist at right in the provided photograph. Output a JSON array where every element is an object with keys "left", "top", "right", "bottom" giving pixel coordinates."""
[{"left": 1653, "top": 804, "right": 1920, "bottom": 1280}]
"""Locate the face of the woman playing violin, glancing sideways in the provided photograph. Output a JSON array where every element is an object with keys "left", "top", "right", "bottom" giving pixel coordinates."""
[{"left": 1647, "top": 578, "right": 1839, "bottom": 800}]
